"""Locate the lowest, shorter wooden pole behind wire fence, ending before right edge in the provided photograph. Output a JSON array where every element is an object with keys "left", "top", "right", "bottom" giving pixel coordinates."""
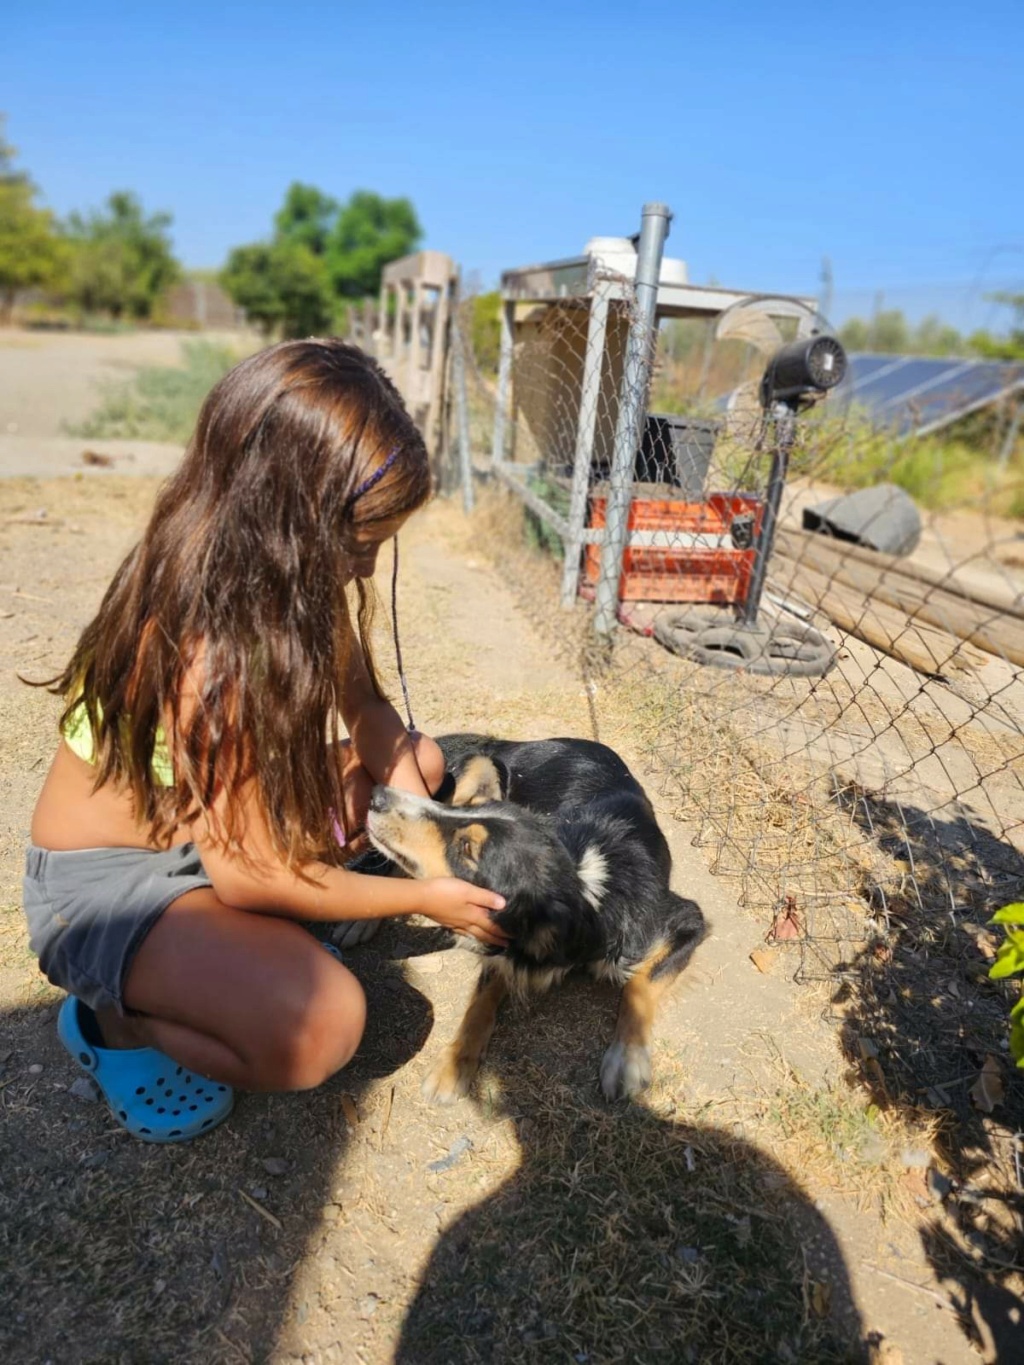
[{"left": 771, "top": 560, "right": 987, "bottom": 677}]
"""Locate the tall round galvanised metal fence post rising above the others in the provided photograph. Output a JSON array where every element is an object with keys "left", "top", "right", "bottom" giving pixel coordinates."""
[{"left": 594, "top": 203, "right": 672, "bottom": 635}]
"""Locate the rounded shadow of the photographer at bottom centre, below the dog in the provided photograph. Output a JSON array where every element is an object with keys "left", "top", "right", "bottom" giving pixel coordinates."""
[{"left": 395, "top": 1026, "right": 866, "bottom": 1365}]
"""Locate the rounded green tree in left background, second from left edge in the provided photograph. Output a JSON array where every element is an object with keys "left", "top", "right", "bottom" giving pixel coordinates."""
[{"left": 67, "top": 190, "right": 182, "bottom": 319}]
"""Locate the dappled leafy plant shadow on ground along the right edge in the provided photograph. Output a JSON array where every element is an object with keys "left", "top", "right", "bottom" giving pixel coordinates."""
[{"left": 836, "top": 796, "right": 1024, "bottom": 1361}]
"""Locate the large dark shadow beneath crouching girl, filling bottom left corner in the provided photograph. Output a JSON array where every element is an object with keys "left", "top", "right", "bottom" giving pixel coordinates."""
[{"left": 0, "top": 949, "right": 433, "bottom": 1365}]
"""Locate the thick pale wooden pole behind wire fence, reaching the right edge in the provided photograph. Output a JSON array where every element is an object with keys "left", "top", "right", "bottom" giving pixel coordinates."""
[{"left": 776, "top": 531, "right": 1024, "bottom": 666}]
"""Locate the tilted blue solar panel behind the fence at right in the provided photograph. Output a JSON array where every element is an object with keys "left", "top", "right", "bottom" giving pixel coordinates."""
[{"left": 836, "top": 351, "right": 1024, "bottom": 437}]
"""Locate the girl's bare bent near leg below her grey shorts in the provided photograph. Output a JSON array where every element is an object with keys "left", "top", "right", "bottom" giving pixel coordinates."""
[{"left": 98, "top": 890, "right": 366, "bottom": 1091}]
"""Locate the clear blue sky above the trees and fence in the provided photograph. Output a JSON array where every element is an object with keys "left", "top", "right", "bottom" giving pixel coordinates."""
[{"left": 8, "top": 0, "right": 1024, "bottom": 325}]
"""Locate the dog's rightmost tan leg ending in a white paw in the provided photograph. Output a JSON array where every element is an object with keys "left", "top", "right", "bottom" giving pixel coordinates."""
[{"left": 601, "top": 902, "right": 705, "bottom": 1100}]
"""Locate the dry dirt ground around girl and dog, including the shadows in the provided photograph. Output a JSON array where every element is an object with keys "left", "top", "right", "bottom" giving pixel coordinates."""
[{"left": 0, "top": 330, "right": 1010, "bottom": 1365}]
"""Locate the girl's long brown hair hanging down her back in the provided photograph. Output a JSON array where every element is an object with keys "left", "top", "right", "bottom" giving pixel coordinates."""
[{"left": 53, "top": 340, "right": 430, "bottom": 867}]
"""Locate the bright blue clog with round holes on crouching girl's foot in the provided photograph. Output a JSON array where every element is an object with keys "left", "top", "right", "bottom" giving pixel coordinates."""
[{"left": 57, "top": 995, "right": 235, "bottom": 1143}]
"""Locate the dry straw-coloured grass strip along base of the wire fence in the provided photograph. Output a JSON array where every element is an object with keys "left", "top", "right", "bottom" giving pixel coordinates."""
[{"left": 478, "top": 485, "right": 1024, "bottom": 1337}]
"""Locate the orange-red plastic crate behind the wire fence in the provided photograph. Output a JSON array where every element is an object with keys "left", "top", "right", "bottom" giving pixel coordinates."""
[{"left": 584, "top": 493, "right": 763, "bottom": 605}]
